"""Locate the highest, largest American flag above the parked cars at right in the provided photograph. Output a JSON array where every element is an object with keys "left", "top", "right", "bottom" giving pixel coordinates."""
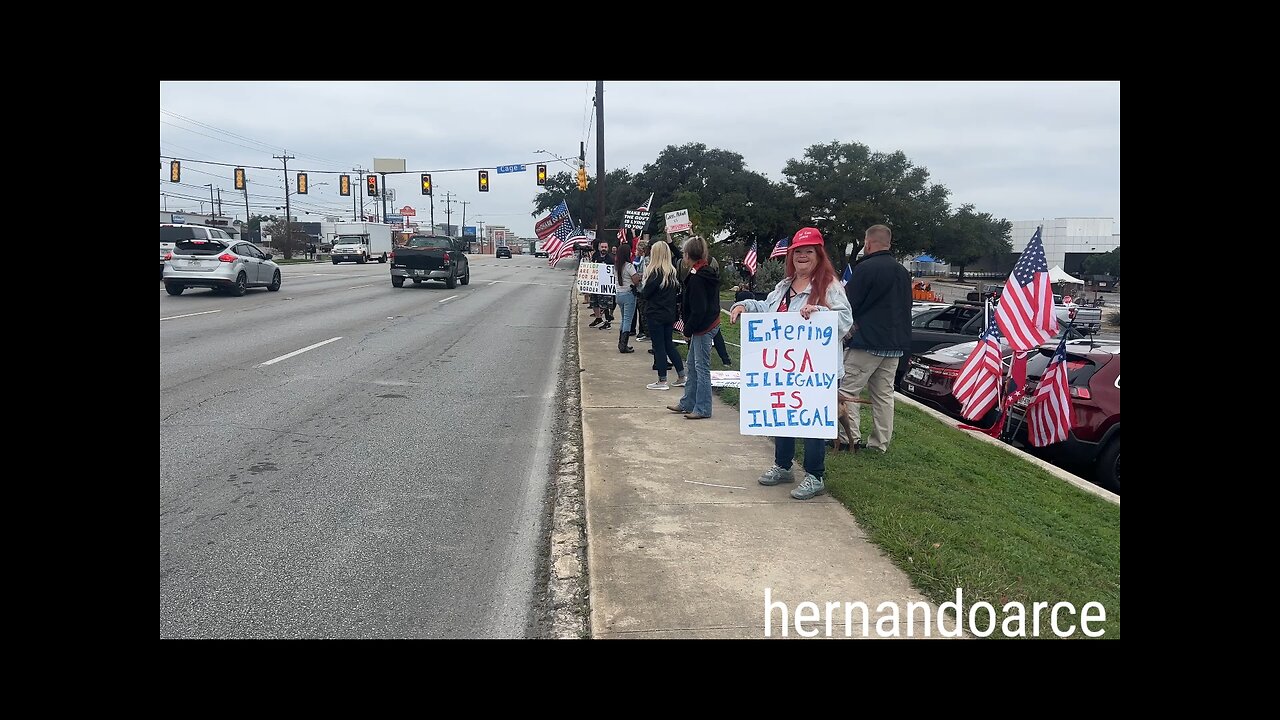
[{"left": 996, "top": 228, "right": 1057, "bottom": 350}]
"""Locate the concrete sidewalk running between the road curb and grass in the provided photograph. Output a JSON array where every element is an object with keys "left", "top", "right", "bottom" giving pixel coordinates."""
[{"left": 575, "top": 295, "right": 937, "bottom": 638}]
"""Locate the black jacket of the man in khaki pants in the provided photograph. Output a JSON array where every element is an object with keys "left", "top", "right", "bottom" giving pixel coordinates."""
[{"left": 845, "top": 250, "right": 911, "bottom": 354}]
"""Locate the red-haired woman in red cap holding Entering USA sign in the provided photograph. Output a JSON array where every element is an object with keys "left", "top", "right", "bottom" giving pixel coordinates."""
[{"left": 730, "top": 228, "right": 854, "bottom": 500}]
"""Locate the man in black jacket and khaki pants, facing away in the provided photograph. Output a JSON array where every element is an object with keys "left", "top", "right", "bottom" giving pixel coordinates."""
[{"left": 841, "top": 225, "right": 911, "bottom": 452}]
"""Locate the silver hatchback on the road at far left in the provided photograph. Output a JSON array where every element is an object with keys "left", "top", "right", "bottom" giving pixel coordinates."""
[{"left": 164, "top": 238, "right": 280, "bottom": 295}]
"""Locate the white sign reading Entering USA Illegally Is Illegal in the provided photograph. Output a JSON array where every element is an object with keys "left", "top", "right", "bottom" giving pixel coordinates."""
[{"left": 739, "top": 310, "right": 841, "bottom": 439}]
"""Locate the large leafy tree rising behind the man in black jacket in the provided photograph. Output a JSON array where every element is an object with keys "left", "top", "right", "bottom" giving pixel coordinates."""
[{"left": 782, "top": 141, "right": 950, "bottom": 265}]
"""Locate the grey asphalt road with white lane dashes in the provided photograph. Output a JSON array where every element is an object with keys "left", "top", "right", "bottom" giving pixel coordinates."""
[{"left": 160, "top": 255, "right": 576, "bottom": 638}]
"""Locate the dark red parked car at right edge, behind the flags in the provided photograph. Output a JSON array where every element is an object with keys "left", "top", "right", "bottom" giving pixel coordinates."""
[{"left": 1006, "top": 342, "right": 1120, "bottom": 493}]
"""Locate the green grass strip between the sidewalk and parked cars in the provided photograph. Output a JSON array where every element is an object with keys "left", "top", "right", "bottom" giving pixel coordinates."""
[{"left": 677, "top": 293, "right": 1120, "bottom": 638}]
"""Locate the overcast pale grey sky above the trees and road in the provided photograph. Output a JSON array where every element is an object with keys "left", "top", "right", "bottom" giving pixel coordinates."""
[{"left": 160, "top": 81, "right": 1120, "bottom": 238}]
